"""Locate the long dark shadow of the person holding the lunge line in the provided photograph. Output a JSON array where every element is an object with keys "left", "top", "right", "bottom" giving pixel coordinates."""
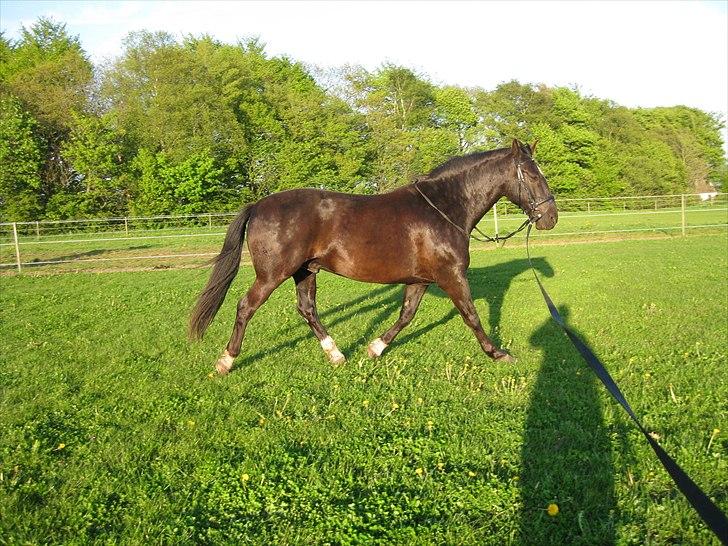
[{"left": 520, "top": 307, "right": 616, "bottom": 544}]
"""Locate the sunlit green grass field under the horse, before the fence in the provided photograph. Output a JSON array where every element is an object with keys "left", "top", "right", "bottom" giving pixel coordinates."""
[{"left": 0, "top": 236, "right": 728, "bottom": 545}]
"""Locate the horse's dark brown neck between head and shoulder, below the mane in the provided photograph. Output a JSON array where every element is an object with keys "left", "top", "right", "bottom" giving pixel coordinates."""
[{"left": 430, "top": 159, "right": 504, "bottom": 233}]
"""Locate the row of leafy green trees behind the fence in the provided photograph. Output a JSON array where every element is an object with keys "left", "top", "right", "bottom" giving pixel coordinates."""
[{"left": 0, "top": 18, "right": 728, "bottom": 221}]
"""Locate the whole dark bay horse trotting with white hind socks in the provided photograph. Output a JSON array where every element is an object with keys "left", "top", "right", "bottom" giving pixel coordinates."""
[{"left": 189, "top": 140, "right": 558, "bottom": 374}]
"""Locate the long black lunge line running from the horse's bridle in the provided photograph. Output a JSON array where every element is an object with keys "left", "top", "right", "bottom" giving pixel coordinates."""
[{"left": 526, "top": 221, "right": 728, "bottom": 545}]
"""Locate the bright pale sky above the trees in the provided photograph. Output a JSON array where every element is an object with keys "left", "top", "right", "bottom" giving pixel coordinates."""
[{"left": 0, "top": 0, "right": 728, "bottom": 136}]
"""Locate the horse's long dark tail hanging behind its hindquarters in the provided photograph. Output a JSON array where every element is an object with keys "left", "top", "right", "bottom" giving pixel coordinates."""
[{"left": 188, "top": 205, "right": 253, "bottom": 339}]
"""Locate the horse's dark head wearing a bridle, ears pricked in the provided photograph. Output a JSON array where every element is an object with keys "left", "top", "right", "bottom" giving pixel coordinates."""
[{"left": 506, "top": 139, "right": 559, "bottom": 229}]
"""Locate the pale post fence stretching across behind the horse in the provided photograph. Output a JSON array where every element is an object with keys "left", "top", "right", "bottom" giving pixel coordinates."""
[{"left": 0, "top": 193, "right": 728, "bottom": 273}]
